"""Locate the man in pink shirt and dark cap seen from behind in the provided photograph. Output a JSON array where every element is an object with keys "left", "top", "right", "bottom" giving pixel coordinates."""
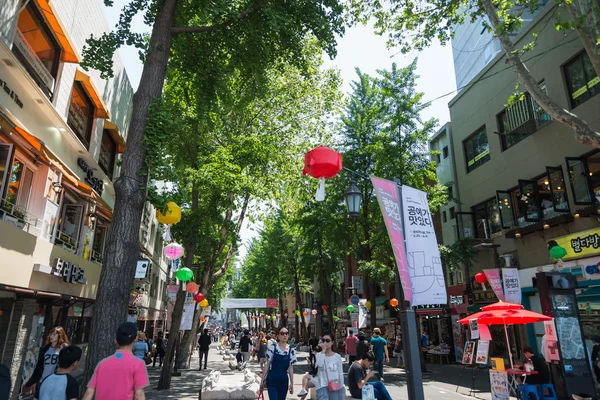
[{"left": 82, "top": 322, "right": 148, "bottom": 400}]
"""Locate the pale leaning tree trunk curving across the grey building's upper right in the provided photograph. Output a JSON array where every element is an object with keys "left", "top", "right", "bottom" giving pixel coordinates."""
[{"left": 481, "top": 0, "right": 600, "bottom": 148}]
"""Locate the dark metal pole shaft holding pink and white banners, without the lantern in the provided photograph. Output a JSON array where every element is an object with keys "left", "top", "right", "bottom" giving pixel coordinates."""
[{"left": 394, "top": 179, "right": 425, "bottom": 400}]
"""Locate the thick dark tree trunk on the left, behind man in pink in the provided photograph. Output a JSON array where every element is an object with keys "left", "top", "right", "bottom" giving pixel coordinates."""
[{"left": 83, "top": 0, "right": 176, "bottom": 382}]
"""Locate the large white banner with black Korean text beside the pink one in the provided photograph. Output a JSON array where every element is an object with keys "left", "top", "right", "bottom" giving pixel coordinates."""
[{"left": 402, "top": 186, "right": 448, "bottom": 306}]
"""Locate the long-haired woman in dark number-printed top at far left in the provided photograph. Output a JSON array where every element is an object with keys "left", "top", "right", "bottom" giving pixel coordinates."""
[{"left": 22, "top": 326, "right": 70, "bottom": 395}]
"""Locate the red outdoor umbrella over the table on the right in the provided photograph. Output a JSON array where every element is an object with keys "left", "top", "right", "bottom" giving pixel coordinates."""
[{"left": 458, "top": 301, "right": 552, "bottom": 368}]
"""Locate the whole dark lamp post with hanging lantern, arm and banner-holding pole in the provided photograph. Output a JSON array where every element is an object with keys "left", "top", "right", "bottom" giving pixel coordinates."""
[{"left": 344, "top": 168, "right": 425, "bottom": 400}]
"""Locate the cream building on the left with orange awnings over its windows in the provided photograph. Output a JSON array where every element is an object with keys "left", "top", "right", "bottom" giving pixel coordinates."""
[{"left": 0, "top": 0, "right": 166, "bottom": 399}]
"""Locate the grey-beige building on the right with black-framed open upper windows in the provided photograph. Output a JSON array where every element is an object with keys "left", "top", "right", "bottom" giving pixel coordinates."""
[{"left": 449, "top": 3, "right": 600, "bottom": 382}]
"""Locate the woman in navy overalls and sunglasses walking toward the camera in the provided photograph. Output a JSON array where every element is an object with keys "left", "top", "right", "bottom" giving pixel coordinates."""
[{"left": 261, "top": 327, "right": 297, "bottom": 400}]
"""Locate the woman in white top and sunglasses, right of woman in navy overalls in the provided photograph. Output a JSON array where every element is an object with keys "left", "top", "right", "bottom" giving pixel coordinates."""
[{"left": 316, "top": 335, "right": 346, "bottom": 400}]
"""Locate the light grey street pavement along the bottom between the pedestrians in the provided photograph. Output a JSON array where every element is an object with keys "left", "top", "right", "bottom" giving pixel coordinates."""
[{"left": 146, "top": 344, "right": 491, "bottom": 400}]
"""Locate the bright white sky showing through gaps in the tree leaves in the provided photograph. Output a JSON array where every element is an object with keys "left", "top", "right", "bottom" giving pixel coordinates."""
[{"left": 105, "top": 0, "right": 456, "bottom": 260}]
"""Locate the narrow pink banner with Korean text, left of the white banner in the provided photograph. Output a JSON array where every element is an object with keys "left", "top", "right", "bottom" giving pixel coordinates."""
[{"left": 371, "top": 176, "right": 412, "bottom": 306}]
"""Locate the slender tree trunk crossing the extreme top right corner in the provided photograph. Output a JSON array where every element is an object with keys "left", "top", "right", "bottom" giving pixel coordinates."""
[{"left": 564, "top": 0, "right": 600, "bottom": 76}]
